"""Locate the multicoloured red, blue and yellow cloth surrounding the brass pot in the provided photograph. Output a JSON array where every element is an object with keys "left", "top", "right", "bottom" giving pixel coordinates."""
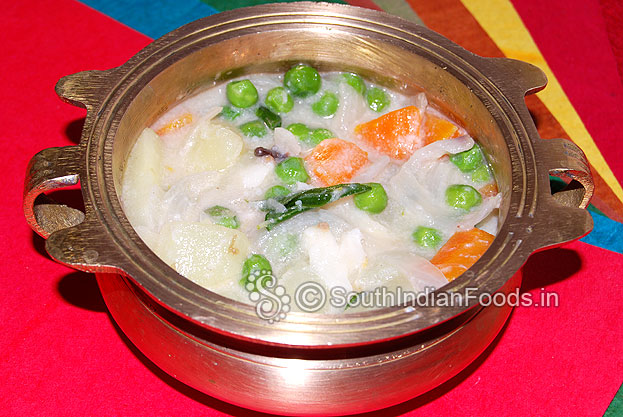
[{"left": 0, "top": 0, "right": 623, "bottom": 417}]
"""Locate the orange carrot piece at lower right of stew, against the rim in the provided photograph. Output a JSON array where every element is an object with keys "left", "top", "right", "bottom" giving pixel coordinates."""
[{"left": 431, "top": 228, "right": 495, "bottom": 281}]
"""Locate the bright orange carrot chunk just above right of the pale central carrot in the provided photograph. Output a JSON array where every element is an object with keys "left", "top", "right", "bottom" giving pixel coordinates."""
[{"left": 355, "top": 106, "right": 425, "bottom": 159}]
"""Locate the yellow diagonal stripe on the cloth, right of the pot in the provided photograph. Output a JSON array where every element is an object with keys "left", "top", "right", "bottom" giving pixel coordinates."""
[{"left": 461, "top": 0, "right": 623, "bottom": 202}]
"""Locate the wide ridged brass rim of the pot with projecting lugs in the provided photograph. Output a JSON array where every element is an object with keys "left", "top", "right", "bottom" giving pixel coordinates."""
[{"left": 25, "top": 2, "right": 592, "bottom": 348}]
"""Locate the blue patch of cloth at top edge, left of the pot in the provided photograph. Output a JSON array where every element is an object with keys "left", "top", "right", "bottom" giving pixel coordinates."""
[{"left": 81, "top": 0, "right": 219, "bottom": 39}]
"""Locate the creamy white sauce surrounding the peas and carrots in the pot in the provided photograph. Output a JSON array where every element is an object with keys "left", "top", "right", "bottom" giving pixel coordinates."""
[{"left": 121, "top": 73, "right": 500, "bottom": 313}]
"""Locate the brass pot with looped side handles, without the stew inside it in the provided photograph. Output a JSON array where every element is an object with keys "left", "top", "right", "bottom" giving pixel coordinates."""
[{"left": 24, "top": 3, "right": 593, "bottom": 415}]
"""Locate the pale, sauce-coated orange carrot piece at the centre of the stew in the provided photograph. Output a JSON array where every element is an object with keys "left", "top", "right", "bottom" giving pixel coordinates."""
[{"left": 305, "top": 138, "right": 368, "bottom": 186}]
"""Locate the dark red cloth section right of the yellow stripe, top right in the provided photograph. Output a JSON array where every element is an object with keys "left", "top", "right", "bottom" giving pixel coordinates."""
[{"left": 512, "top": 0, "right": 623, "bottom": 182}]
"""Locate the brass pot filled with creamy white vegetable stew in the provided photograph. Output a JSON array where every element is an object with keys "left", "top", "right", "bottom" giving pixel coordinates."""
[{"left": 24, "top": 3, "right": 592, "bottom": 415}]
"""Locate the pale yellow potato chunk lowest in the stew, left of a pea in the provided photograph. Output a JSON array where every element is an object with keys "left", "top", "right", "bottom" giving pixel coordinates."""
[{"left": 155, "top": 222, "right": 249, "bottom": 289}]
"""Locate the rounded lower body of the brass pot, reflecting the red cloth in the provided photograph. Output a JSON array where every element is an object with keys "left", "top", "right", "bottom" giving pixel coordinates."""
[{"left": 96, "top": 271, "right": 521, "bottom": 416}]
